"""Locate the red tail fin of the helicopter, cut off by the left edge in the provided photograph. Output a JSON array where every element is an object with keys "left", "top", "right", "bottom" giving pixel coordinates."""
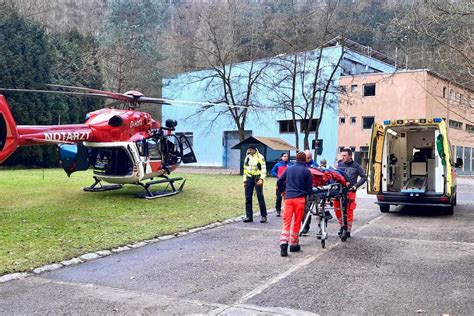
[{"left": 0, "top": 95, "right": 19, "bottom": 163}]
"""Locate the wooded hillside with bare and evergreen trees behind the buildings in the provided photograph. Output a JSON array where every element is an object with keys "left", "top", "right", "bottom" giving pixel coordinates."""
[{"left": 0, "top": 0, "right": 474, "bottom": 165}]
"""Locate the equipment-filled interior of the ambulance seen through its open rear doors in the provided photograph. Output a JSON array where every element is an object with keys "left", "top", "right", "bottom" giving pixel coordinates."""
[{"left": 382, "top": 126, "right": 445, "bottom": 196}]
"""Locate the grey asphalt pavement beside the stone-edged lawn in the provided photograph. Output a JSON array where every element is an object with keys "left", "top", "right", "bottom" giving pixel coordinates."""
[{"left": 0, "top": 178, "right": 474, "bottom": 315}]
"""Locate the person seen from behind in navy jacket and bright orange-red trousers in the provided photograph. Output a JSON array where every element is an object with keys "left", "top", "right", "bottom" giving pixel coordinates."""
[{"left": 277, "top": 152, "right": 312, "bottom": 257}]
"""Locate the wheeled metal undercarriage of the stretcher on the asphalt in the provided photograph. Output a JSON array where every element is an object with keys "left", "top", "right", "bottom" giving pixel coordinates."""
[{"left": 299, "top": 183, "right": 349, "bottom": 248}]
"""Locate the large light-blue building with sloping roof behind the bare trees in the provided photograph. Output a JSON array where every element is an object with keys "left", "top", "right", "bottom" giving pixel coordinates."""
[{"left": 162, "top": 39, "right": 396, "bottom": 169}]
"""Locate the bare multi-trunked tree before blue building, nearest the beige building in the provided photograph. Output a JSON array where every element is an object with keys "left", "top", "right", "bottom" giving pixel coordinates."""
[{"left": 266, "top": 1, "right": 347, "bottom": 156}]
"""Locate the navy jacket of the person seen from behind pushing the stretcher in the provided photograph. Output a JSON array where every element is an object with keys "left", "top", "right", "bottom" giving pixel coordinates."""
[{"left": 277, "top": 162, "right": 312, "bottom": 199}]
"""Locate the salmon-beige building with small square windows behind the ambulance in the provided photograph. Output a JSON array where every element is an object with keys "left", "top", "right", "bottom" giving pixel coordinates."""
[{"left": 338, "top": 70, "right": 474, "bottom": 174}]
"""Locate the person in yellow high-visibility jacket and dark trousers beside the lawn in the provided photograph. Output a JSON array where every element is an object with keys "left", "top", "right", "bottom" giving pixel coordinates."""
[{"left": 243, "top": 145, "right": 267, "bottom": 223}]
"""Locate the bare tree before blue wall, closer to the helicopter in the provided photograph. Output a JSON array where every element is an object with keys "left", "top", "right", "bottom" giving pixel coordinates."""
[{"left": 166, "top": 1, "right": 268, "bottom": 141}]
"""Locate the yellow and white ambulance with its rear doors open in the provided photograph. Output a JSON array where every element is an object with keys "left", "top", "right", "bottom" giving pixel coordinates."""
[{"left": 367, "top": 118, "right": 463, "bottom": 215}]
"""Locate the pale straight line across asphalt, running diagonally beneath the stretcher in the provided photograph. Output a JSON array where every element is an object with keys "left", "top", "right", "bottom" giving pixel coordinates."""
[{"left": 235, "top": 214, "right": 386, "bottom": 304}]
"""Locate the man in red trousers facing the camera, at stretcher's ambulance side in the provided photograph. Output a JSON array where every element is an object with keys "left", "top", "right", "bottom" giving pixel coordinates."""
[{"left": 334, "top": 148, "right": 367, "bottom": 237}]
